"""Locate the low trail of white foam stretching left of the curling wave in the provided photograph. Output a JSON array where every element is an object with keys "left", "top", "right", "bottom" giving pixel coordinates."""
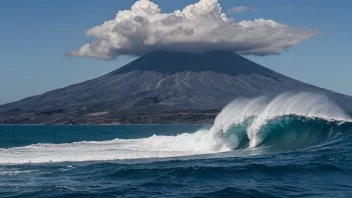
[{"left": 0, "top": 130, "right": 226, "bottom": 164}]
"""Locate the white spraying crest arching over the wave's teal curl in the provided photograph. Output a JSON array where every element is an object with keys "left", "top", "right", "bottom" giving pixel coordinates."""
[{"left": 211, "top": 92, "right": 350, "bottom": 148}]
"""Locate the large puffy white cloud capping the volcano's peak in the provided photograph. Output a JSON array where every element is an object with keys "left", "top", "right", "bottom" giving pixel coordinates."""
[{"left": 67, "top": 0, "right": 320, "bottom": 60}]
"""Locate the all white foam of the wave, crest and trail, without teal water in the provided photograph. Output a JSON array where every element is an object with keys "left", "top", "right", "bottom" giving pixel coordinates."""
[{"left": 0, "top": 92, "right": 350, "bottom": 164}]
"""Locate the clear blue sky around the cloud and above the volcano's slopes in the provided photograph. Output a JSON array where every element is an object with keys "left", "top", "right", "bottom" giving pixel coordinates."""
[{"left": 0, "top": 0, "right": 352, "bottom": 103}]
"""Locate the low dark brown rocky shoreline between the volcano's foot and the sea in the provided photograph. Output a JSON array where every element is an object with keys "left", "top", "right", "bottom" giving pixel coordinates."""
[{"left": 0, "top": 110, "right": 219, "bottom": 125}]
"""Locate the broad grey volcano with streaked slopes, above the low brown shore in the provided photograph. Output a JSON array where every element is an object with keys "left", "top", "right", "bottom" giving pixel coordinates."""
[{"left": 0, "top": 51, "right": 352, "bottom": 123}]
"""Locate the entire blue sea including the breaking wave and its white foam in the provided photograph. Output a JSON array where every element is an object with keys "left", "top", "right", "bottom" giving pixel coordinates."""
[{"left": 0, "top": 93, "right": 352, "bottom": 198}]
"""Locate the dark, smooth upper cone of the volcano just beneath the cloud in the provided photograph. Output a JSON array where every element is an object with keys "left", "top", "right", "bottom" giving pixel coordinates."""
[{"left": 113, "top": 51, "right": 275, "bottom": 77}]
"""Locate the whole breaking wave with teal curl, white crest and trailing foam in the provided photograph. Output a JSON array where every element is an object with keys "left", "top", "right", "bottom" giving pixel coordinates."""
[{"left": 0, "top": 92, "right": 352, "bottom": 164}]
